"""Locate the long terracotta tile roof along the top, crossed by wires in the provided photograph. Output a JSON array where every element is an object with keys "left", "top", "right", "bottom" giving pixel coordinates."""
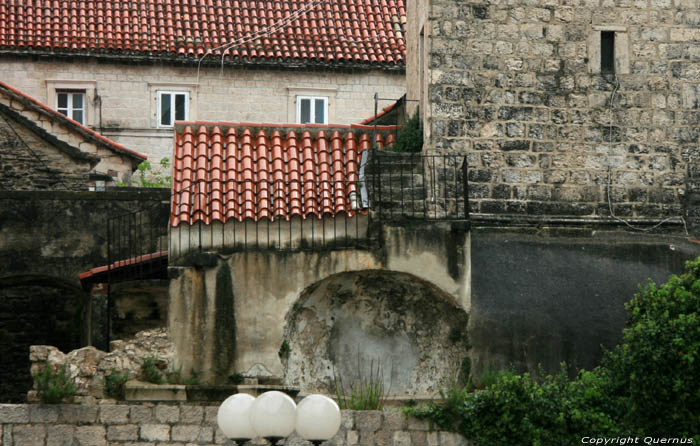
[{"left": 0, "top": 0, "right": 406, "bottom": 66}]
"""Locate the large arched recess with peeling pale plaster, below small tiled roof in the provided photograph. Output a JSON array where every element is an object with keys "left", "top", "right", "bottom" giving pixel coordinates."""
[{"left": 280, "top": 270, "right": 469, "bottom": 396}]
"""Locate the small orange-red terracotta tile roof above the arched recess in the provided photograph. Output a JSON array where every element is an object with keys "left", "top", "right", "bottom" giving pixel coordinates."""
[{"left": 170, "top": 122, "right": 396, "bottom": 226}]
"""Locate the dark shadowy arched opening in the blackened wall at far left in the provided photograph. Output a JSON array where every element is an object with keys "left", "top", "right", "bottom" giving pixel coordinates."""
[{"left": 0, "top": 274, "right": 86, "bottom": 402}]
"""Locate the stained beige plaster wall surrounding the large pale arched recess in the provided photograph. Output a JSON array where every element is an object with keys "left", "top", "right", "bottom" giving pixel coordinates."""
[{"left": 168, "top": 223, "right": 469, "bottom": 388}]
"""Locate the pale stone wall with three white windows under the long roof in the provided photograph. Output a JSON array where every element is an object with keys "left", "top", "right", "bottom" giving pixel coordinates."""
[{"left": 0, "top": 56, "right": 406, "bottom": 162}]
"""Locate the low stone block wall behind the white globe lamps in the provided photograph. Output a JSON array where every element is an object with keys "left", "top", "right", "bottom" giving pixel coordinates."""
[{"left": 0, "top": 404, "right": 472, "bottom": 446}]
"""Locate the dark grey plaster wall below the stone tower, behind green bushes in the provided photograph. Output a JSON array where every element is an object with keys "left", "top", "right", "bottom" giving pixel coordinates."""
[{"left": 469, "top": 227, "right": 700, "bottom": 382}]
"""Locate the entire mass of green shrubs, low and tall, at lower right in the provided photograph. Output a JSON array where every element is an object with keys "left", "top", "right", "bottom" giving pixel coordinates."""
[{"left": 404, "top": 258, "right": 700, "bottom": 446}]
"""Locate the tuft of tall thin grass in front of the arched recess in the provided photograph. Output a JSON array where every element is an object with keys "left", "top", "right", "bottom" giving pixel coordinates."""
[{"left": 335, "top": 354, "right": 387, "bottom": 410}]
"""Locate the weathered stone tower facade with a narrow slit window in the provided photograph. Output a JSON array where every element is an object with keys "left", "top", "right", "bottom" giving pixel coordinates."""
[{"left": 407, "top": 0, "right": 700, "bottom": 228}]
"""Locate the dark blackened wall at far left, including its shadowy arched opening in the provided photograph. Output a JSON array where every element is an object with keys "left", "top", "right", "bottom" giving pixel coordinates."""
[{"left": 0, "top": 190, "right": 169, "bottom": 401}]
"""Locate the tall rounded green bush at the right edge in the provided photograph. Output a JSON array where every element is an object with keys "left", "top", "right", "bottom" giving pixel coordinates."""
[{"left": 601, "top": 258, "right": 700, "bottom": 436}]
